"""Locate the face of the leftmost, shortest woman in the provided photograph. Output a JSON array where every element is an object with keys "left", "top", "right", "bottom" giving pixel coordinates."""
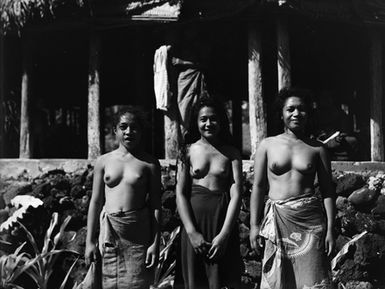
[{"left": 115, "top": 113, "right": 142, "bottom": 149}]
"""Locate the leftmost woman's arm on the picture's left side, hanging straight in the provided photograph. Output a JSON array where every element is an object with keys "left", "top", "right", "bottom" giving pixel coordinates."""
[{"left": 85, "top": 156, "right": 104, "bottom": 265}]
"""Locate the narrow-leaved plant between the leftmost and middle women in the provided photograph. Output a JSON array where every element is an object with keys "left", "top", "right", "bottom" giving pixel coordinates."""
[{"left": 151, "top": 226, "right": 180, "bottom": 289}]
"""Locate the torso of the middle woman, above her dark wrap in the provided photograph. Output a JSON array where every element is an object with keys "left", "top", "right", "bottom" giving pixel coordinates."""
[{"left": 189, "top": 141, "right": 233, "bottom": 191}]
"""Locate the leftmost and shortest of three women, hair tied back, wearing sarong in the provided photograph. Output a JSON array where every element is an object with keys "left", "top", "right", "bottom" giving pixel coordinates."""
[{"left": 85, "top": 107, "right": 161, "bottom": 289}]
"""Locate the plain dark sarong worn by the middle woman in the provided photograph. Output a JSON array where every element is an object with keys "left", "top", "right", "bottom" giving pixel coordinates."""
[{"left": 181, "top": 185, "right": 241, "bottom": 289}]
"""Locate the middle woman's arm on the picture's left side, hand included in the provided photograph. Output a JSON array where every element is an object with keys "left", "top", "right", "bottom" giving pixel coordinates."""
[{"left": 176, "top": 152, "right": 210, "bottom": 254}]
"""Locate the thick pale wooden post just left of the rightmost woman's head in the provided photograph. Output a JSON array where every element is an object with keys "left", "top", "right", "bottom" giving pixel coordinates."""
[{"left": 248, "top": 23, "right": 267, "bottom": 159}]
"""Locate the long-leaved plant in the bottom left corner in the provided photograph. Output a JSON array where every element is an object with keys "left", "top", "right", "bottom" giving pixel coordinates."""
[{"left": 0, "top": 212, "right": 79, "bottom": 289}]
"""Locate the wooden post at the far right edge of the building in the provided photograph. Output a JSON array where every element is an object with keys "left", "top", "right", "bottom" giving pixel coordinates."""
[{"left": 370, "top": 31, "right": 384, "bottom": 161}]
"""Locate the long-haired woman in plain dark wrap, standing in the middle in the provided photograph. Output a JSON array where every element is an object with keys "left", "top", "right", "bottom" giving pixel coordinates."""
[{"left": 176, "top": 97, "right": 242, "bottom": 289}]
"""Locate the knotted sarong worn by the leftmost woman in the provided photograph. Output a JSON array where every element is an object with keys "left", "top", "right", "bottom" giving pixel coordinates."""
[{"left": 99, "top": 208, "right": 154, "bottom": 289}]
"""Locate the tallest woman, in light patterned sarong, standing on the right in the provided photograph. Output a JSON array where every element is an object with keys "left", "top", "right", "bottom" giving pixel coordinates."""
[{"left": 250, "top": 89, "right": 335, "bottom": 289}]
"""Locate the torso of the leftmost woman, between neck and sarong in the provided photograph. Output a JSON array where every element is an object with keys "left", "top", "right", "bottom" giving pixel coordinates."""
[{"left": 103, "top": 151, "right": 151, "bottom": 213}]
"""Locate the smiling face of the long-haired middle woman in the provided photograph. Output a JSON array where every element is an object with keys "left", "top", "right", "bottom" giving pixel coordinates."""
[{"left": 198, "top": 106, "right": 220, "bottom": 140}]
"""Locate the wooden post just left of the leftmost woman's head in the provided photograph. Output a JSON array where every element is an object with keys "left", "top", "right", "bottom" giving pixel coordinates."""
[{"left": 87, "top": 33, "right": 101, "bottom": 159}]
